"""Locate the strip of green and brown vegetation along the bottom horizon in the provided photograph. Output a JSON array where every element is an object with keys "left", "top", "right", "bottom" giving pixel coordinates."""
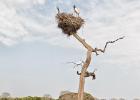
[{"left": 0, "top": 91, "right": 133, "bottom": 100}]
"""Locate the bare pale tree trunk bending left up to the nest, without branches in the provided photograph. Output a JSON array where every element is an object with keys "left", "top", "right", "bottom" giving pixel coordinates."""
[{"left": 73, "top": 34, "right": 93, "bottom": 100}]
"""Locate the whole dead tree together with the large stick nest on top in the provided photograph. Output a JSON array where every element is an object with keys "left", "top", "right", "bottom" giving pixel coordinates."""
[{"left": 56, "top": 7, "right": 124, "bottom": 100}]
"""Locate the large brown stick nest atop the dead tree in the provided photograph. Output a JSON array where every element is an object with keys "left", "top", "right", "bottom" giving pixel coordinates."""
[{"left": 56, "top": 13, "right": 84, "bottom": 36}]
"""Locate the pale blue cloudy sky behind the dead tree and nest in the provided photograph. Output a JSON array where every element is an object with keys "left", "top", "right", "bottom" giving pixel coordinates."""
[{"left": 0, "top": 0, "right": 140, "bottom": 100}]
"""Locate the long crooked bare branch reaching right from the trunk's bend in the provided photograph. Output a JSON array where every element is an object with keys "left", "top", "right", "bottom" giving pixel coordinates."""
[{"left": 94, "top": 36, "right": 125, "bottom": 55}]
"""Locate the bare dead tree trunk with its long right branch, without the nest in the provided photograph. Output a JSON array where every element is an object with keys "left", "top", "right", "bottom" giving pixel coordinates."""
[{"left": 73, "top": 34, "right": 124, "bottom": 100}]
